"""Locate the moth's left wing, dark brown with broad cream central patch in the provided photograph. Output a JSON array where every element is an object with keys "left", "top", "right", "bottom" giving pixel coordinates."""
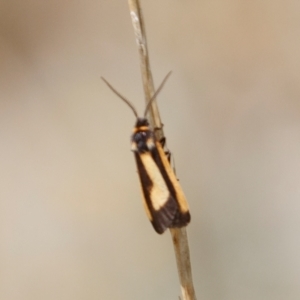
[{"left": 135, "top": 152, "right": 178, "bottom": 233}]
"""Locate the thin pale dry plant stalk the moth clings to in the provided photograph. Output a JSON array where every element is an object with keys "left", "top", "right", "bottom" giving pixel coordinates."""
[{"left": 128, "top": 0, "right": 196, "bottom": 300}]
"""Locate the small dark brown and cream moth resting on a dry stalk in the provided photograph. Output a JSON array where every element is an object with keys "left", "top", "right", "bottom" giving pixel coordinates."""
[{"left": 102, "top": 72, "right": 191, "bottom": 234}]
